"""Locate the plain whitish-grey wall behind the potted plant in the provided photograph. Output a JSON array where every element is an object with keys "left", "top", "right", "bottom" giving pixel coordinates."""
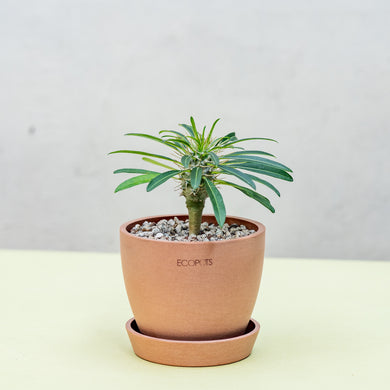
[{"left": 0, "top": 0, "right": 390, "bottom": 260}]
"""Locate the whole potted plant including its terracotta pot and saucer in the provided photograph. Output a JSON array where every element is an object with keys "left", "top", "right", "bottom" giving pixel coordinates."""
[{"left": 110, "top": 117, "right": 293, "bottom": 365}]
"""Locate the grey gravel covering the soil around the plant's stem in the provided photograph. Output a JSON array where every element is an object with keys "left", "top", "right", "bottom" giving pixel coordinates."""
[{"left": 130, "top": 217, "right": 255, "bottom": 241}]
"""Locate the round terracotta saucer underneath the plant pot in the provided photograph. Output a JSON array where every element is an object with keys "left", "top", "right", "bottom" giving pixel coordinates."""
[{"left": 126, "top": 318, "right": 260, "bottom": 367}]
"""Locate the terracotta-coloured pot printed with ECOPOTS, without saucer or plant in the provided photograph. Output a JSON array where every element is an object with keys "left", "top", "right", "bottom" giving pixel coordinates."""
[{"left": 120, "top": 215, "right": 265, "bottom": 340}]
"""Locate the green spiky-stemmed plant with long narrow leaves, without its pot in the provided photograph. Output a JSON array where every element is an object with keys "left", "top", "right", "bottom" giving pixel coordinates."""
[{"left": 109, "top": 117, "right": 293, "bottom": 234}]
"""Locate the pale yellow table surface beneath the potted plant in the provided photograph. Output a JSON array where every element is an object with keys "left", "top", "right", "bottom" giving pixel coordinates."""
[{"left": 0, "top": 250, "right": 390, "bottom": 390}]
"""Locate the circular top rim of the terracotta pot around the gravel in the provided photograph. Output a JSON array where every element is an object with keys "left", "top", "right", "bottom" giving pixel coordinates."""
[{"left": 119, "top": 214, "right": 265, "bottom": 245}]
